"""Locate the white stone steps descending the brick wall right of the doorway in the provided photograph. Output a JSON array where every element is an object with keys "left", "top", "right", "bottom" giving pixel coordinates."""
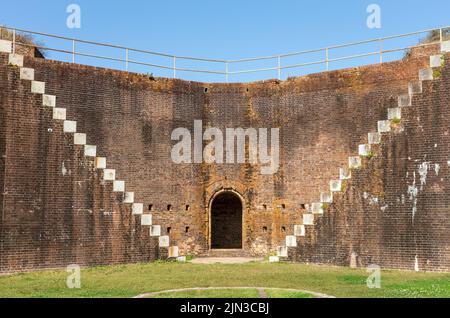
[{"left": 272, "top": 41, "right": 450, "bottom": 261}]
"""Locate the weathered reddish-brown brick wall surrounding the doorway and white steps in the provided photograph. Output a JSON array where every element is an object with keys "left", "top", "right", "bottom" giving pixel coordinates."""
[{"left": 0, "top": 44, "right": 450, "bottom": 271}]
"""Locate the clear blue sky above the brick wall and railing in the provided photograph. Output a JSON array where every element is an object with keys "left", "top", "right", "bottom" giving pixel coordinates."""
[{"left": 0, "top": 0, "right": 450, "bottom": 80}]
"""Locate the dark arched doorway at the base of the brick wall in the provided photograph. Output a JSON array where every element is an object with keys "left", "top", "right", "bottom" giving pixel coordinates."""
[{"left": 211, "top": 191, "right": 242, "bottom": 249}]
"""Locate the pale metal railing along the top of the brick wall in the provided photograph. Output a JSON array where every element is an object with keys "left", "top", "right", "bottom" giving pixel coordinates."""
[{"left": 0, "top": 26, "right": 450, "bottom": 82}]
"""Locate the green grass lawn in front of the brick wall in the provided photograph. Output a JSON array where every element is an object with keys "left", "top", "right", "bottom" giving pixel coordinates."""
[{"left": 0, "top": 262, "right": 450, "bottom": 297}]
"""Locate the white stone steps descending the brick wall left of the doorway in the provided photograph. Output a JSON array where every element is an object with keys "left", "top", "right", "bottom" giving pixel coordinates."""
[{"left": 0, "top": 40, "right": 183, "bottom": 258}]
